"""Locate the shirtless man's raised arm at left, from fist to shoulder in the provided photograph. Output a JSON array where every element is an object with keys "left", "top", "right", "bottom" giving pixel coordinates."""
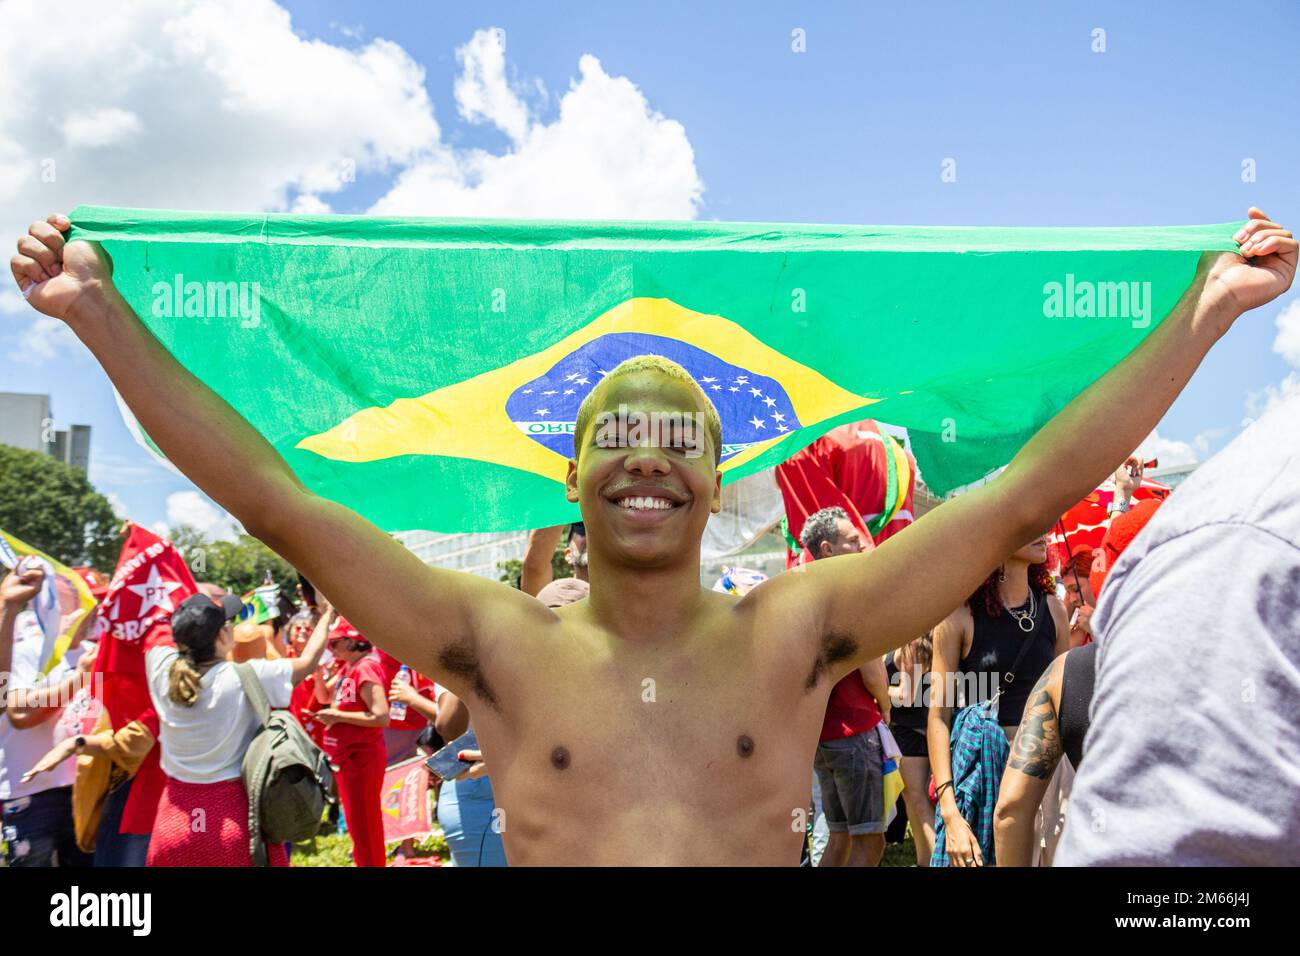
[{"left": 10, "top": 216, "right": 540, "bottom": 700}]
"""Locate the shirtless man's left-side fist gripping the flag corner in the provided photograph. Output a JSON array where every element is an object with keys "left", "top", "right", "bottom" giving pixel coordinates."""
[{"left": 9, "top": 213, "right": 113, "bottom": 321}]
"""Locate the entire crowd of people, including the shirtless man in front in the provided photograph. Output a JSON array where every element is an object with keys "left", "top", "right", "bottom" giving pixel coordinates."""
[{"left": 0, "top": 209, "right": 1300, "bottom": 866}]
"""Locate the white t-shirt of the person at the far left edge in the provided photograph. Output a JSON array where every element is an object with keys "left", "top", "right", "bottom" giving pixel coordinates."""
[{"left": 0, "top": 610, "right": 81, "bottom": 800}]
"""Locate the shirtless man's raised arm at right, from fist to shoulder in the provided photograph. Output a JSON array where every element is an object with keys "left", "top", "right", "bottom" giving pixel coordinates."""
[{"left": 805, "top": 208, "right": 1296, "bottom": 679}]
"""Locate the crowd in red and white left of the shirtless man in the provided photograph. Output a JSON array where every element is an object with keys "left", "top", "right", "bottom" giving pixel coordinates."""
[{"left": 0, "top": 524, "right": 598, "bottom": 868}]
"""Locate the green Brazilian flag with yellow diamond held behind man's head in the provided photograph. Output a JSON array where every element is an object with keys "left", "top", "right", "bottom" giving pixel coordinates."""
[{"left": 72, "top": 207, "right": 1239, "bottom": 531}]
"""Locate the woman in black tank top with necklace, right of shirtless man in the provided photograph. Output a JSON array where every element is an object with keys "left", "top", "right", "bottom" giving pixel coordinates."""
[{"left": 928, "top": 537, "right": 1070, "bottom": 860}]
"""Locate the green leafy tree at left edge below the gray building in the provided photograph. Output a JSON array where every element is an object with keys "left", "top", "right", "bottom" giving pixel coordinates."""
[{"left": 0, "top": 445, "right": 122, "bottom": 572}]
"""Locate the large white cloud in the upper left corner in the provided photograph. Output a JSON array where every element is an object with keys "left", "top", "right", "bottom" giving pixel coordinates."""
[{"left": 0, "top": 0, "right": 439, "bottom": 261}]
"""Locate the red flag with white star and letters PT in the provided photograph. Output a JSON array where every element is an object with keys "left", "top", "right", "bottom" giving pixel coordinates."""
[{"left": 95, "top": 524, "right": 199, "bottom": 730}]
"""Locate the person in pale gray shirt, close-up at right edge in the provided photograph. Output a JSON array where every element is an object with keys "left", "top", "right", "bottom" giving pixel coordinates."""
[{"left": 1056, "top": 392, "right": 1300, "bottom": 866}]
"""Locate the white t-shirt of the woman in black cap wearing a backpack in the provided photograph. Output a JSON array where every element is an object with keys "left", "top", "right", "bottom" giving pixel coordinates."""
[{"left": 144, "top": 646, "right": 294, "bottom": 783}]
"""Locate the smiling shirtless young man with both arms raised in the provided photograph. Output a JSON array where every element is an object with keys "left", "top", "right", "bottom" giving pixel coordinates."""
[{"left": 10, "top": 209, "right": 1296, "bottom": 865}]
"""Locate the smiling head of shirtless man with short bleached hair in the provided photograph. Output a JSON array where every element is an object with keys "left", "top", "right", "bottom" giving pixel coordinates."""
[{"left": 567, "top": 369, "right": 722, "bottom": 567}]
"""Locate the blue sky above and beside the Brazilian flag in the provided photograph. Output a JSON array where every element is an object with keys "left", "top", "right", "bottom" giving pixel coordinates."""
[{"left": 0, "top": 0, "right": 1300, "bottom": 535}]
